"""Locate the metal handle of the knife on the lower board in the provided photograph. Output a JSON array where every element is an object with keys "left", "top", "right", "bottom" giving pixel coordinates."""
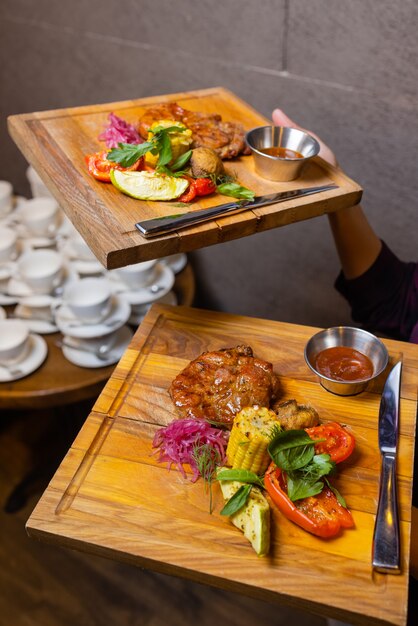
[{"left": 372, "top": 454, "right": 401, "bottom": 574}]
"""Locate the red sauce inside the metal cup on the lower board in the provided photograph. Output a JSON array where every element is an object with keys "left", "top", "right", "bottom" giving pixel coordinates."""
[{"left": 315, "top": 346, "right": 373, "bottom": 381}]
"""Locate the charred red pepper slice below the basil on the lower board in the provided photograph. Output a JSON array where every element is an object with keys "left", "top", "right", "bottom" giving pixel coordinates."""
[{"left": 264, "top": 463, "right": 354, "bottom": 538}]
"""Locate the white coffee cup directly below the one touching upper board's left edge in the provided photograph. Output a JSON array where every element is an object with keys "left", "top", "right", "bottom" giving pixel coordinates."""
[{"left": 17, "top": 250, "right": 64, "bottom": 294}]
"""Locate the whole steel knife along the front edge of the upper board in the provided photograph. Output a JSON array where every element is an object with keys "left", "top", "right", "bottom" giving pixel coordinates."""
[{"left": 135, "top": 185, "right": 338, "bottom": 239}]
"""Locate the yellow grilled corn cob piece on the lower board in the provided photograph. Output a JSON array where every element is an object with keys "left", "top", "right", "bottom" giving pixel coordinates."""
[{"left": 226, "top": 406, "right": 277, "bottom": 474}]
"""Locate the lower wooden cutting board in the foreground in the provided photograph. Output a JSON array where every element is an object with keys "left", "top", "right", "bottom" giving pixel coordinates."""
[{"left": 27, "top": 305, "right": 418, "bottom": 626}]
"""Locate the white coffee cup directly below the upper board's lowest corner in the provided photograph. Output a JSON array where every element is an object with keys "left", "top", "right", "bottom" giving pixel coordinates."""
[{"left": 63, "top": 278, "right": 112, "bottom": 323}]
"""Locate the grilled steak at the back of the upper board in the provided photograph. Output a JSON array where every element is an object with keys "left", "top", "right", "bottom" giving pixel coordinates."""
[{"left": 138, "top": 102, "right": 249, "bottom": 159}]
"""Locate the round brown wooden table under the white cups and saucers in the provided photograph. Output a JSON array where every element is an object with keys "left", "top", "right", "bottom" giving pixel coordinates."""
[{"left": 0, "top": 264, "right": 195, "bottom": 410}]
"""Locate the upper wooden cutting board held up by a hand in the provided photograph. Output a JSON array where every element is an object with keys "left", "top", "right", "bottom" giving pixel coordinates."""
[{"left": 8, "top": 87, "right": 362, "bottom": 269}]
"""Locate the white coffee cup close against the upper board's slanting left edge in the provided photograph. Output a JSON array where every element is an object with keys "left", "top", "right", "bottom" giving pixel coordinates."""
[{"left": 19, "top": 198, "right": 60, "bottom": 237}]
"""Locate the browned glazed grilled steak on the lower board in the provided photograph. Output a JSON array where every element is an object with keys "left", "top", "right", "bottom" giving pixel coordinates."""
[{"left": 169, "top": 346, "right": 279, "bottom": 425}]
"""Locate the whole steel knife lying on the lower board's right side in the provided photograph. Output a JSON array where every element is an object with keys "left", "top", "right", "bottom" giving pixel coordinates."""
[{"left": 372, "top": 361, "right": 402, "bottom": 574}]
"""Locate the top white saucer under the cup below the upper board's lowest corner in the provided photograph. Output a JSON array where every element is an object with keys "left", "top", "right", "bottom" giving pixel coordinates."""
[{"left": 55, "top": 295, "right": 131, "bottom": 339}]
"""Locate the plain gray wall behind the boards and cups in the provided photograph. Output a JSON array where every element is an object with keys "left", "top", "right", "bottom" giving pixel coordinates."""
[{"left": 0, "top": 0, "right": 418, "bottom": 326}]
